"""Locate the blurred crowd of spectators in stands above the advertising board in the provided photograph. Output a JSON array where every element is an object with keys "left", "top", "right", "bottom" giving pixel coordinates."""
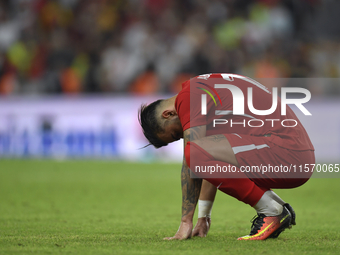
[{"left": 0, "top": 0, "right": 340, "bottom": 95}]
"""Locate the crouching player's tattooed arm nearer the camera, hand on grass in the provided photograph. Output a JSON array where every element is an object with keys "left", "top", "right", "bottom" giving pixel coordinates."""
[{"left": 165, "top": 126, "right": 206, "bottom": 240}]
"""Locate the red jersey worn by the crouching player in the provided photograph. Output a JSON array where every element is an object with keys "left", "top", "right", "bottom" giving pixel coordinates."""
[{"left": 175, "top": 74, "right": 314, "bottom": 151}]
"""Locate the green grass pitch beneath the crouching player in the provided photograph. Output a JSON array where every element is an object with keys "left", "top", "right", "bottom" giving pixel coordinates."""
[{"left": 0, "top": 160, "right": 340, "bottom": 255}]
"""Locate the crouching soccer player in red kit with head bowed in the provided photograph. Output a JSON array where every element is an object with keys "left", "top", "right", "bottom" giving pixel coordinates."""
[{"left": 139, "top": 74, "right": 315, "bottom": 240}]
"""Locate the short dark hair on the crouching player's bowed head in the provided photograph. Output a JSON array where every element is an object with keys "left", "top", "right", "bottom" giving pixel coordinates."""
[{"left": 138, "top": 100, "right": 168, "bottom": 149}]
